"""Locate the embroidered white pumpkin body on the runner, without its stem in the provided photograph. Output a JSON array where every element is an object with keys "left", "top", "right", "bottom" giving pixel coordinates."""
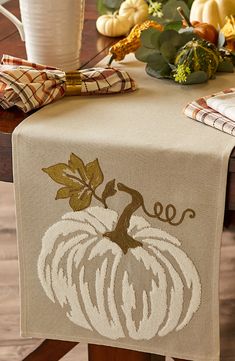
[{"left": 38, "top": 207, "right": 201, "bottom": 340}]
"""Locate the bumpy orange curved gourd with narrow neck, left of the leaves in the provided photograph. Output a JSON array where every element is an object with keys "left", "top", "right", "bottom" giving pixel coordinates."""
[{"left": 108, "top": 20, "right": 163, "bottom": 65}]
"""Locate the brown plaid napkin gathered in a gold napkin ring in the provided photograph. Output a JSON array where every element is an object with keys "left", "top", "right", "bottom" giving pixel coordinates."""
[{"left": 0, "top": 55, "right": 136, "bottom": 112}]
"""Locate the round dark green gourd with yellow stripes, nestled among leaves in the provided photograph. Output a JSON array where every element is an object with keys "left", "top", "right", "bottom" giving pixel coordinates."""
[{"left": 174, "top": 39, "right": 220, "bottom": 83}]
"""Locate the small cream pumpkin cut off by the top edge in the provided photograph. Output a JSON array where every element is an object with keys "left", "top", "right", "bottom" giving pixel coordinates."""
[{"left": 119, "top": 0, "right": 148, "bottom": 26}]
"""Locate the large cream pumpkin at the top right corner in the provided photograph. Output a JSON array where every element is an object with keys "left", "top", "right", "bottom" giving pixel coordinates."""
[{"left": 190, "top": 0, "right": 235, "bottom": 29}]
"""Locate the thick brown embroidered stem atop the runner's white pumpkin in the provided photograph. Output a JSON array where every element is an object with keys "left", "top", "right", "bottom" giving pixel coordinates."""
[{"left": 104, "top": 183, "right": 143, "bottom": 254}]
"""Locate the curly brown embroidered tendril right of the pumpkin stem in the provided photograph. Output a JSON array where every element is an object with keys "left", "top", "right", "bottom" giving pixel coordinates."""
[{"left": 142, "top": 202, "right": 196, "bottom": 226}]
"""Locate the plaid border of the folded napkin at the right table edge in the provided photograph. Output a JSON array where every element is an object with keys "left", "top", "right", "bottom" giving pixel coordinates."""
[{"left": 184, "top": 88, "right": 235, "bottom": 136}]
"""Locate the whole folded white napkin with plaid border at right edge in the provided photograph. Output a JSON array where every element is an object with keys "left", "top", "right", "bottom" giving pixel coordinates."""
[{"left": 184, "top": 88, "right": 235, "bottom": 136}]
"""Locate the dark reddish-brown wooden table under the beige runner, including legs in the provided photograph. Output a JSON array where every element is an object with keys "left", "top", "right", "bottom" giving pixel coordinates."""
[{"left": 0, "top": 0, "right": 235, "bottom": 361}]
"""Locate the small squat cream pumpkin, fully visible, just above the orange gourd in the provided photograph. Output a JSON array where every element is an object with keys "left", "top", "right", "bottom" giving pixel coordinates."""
[{"left": 96, "top": 13, "right": 131, "bottom": 37}]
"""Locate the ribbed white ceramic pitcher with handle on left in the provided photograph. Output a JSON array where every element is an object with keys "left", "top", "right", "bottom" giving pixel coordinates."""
[{"left": 0, "top": 0, "right": 85, "bottom": 71}]
